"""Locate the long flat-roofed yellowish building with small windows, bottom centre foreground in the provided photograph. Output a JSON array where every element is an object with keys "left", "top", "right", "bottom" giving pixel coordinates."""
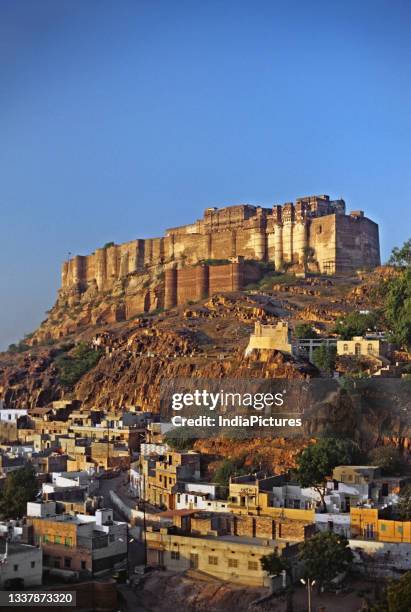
[{"left": 146, "top": 510, "right": 310, "bottom": 586}]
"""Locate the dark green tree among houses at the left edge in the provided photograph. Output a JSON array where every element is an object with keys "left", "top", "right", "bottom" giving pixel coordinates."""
[{"left": 0, "top": 464, "right": 38, "bottom": 520}]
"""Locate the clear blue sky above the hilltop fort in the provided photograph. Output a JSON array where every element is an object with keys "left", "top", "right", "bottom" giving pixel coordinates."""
[{"left": 0, "top": 0, "right": 411, "bottom": 348}]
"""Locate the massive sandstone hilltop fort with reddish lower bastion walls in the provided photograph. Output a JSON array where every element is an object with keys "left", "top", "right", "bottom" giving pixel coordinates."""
[{"left": 60, "top": 195, "right": 380, "bottom": 318}]
